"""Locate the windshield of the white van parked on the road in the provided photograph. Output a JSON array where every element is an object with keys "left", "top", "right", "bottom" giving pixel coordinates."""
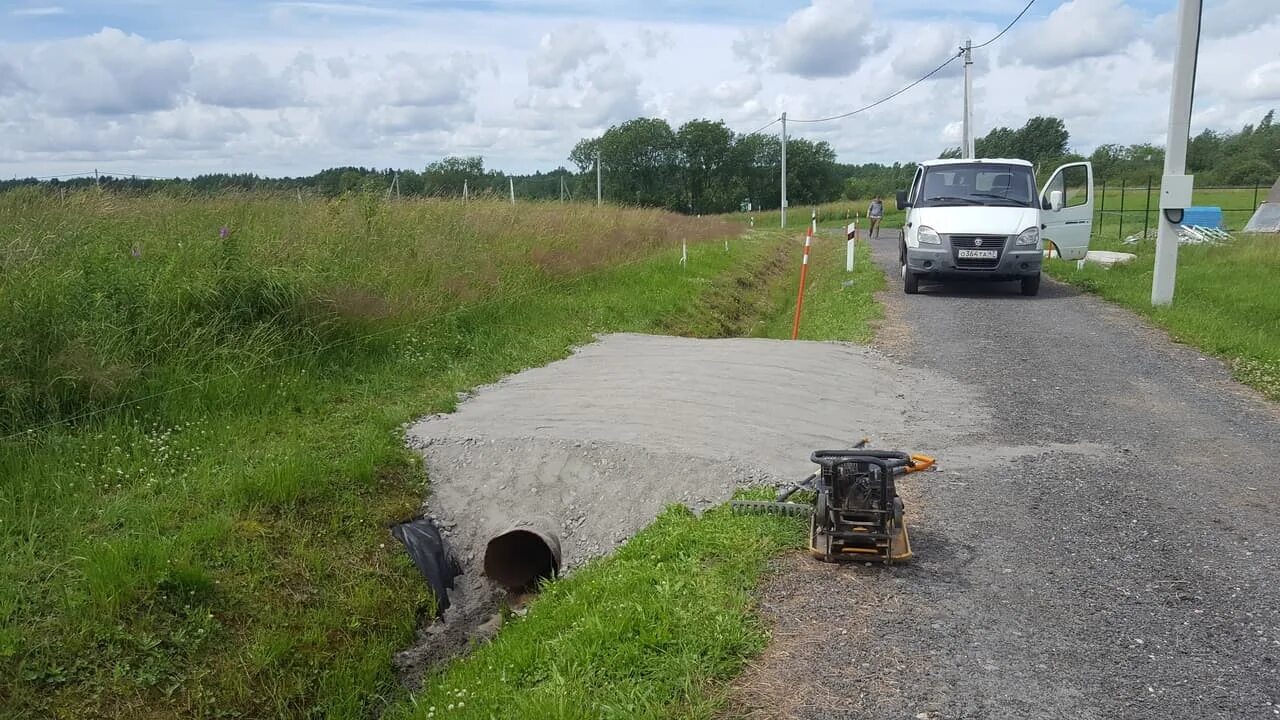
[{"left": 916, "top": 163, "right": 1036, "bottom": 208}]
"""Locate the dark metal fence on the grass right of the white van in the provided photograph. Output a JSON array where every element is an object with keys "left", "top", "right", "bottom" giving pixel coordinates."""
[{"left": 1093, "top": 176, "right": 1270, "bottom": 240}]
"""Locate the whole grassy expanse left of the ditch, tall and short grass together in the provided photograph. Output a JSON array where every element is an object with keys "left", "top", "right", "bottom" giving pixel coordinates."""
[{"left": 0, "top": 191, "right": 778, "bottom": 717}]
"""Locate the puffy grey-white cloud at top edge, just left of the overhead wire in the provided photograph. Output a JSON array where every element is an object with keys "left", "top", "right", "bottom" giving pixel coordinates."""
[{"left": 773, "top": 0, "right": 879, "bottom": 78}]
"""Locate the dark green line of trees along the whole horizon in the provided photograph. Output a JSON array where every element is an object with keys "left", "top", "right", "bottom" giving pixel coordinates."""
[{"left": 0, "top": 110, "right": 1280, "bottom": 207}]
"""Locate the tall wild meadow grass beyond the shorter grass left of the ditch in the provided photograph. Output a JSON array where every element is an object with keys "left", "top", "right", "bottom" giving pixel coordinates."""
[{"left": 0, "top": 188, "right": 724, "bottom": 433}]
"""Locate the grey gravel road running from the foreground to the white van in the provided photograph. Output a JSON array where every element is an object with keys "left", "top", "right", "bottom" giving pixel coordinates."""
[{"left": 727, "top": 235, "right": 1280, "bottom": 720}]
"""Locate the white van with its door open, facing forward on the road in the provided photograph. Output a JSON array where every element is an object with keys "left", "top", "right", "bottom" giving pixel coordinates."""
[{"left": 897, "top": 159, "right": 1093, "bottom": 295}]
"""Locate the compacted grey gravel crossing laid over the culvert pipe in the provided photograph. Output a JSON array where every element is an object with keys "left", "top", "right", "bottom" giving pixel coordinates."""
[{"left": 399, "top": 334, "right": 1018, "bottom": 682}]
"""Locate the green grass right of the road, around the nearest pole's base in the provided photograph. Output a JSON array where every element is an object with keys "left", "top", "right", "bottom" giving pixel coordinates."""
[{"left": 1046, "top": 236, "right": 1280, "bottom": 400}]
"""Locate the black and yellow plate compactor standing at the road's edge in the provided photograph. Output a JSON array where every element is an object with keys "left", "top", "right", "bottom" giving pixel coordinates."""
[{"left": 731, "top": 441, "right": 934, "bottom": 562}]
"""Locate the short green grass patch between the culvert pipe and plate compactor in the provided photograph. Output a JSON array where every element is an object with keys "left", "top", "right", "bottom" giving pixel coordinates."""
[{"left": 388, "top": 493, "right": 804, "bottom": 720}]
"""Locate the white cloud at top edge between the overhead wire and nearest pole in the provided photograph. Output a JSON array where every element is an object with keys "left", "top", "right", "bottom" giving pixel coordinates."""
[{"left": 1010, "top": 0, "right": 1139, "bottom": 68}]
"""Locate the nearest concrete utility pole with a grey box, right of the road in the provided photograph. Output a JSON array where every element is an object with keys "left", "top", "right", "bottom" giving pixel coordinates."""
[{"left": 1151, "top": 0, "right": 1202, "bottom": 305}]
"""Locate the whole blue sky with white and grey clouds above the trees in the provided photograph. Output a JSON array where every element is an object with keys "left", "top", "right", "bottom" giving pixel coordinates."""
[{"left": 0, "top": 0, "right": 1280, "bottom": 178}]
